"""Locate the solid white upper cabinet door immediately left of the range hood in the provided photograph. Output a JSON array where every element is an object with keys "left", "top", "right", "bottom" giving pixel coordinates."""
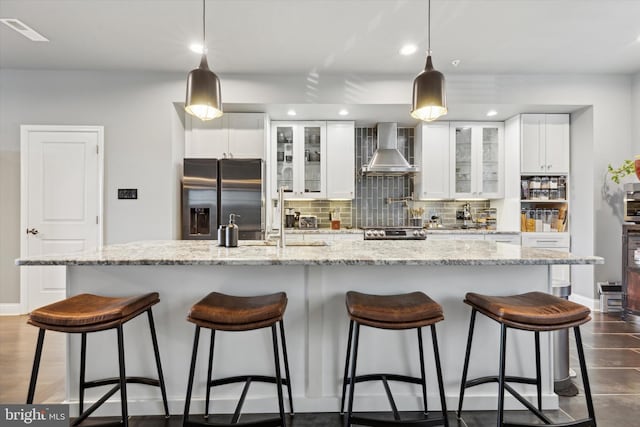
[{"left": 326, "top": 121, "right": 356, "bottom": 199}]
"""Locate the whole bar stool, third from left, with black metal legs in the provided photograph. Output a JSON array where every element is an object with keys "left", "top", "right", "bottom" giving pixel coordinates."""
[{"left": 340, "top": 291, "right": 449, "bottom": 427}]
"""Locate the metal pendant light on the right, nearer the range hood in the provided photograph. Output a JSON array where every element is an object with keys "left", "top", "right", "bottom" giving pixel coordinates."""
[{"left": 411, "top": 0, "right": 447, "bottom": 122}]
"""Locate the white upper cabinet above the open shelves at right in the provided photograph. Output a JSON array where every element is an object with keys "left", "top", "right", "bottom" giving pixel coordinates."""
[{"left": 520, "top": 114, "right": 570, "bottom": 174}]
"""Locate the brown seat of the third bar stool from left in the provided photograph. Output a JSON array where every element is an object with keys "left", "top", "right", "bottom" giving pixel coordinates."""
[{"left": 346, "top": 291, "right": 444, "bottom": 329}]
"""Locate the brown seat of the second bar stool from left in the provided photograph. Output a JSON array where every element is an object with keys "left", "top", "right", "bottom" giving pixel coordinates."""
[{"left": 187, "top": 292, "right": 287, "bottom": 331}]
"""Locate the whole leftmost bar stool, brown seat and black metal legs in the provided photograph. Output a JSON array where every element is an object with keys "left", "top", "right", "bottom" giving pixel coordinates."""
[{"left": 27, "top": 292, "right": 169, "bottom": 427}]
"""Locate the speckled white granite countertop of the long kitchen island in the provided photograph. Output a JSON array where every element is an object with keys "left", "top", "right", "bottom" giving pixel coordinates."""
[{"left": 16, "top": 239, "right": 604, "bottom": 265}]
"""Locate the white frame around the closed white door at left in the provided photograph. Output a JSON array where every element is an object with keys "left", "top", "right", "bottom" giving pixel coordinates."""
[{"left": 19, "top": 125, "right": 104, "bottom": 314}]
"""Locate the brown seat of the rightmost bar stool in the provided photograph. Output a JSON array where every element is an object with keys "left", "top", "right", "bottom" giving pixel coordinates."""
[{"left": 464, "top": 292, "right": 591, "bottom": 331}]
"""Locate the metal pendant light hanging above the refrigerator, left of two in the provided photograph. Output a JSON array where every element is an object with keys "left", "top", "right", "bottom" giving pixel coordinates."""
[{"left": 185, "top": 0, "right": 222, "bottom": 121}]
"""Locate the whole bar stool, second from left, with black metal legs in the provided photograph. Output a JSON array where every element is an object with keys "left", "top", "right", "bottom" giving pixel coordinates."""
[{"left": 183, "top": 292, "right": 293, "bottom": 427}]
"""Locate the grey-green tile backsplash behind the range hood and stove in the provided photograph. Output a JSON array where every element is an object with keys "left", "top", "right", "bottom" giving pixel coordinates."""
[{"left": 285, "top": 127, "right": 489, "bottom": 228}]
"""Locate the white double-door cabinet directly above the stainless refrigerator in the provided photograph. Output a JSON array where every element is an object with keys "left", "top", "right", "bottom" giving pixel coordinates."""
[{"left": 184, "top": 113, "right": 267, "bottom": 159}]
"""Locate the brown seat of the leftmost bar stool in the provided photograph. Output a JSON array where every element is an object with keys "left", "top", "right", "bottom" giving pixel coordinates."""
[{"left": 27, "top": 292, "right": 160, "bottom": 332}]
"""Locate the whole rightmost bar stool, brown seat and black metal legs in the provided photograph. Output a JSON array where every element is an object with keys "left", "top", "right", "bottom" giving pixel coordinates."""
[{"left": 457, "top": 292, "right": 596, "bottom": 427}]
